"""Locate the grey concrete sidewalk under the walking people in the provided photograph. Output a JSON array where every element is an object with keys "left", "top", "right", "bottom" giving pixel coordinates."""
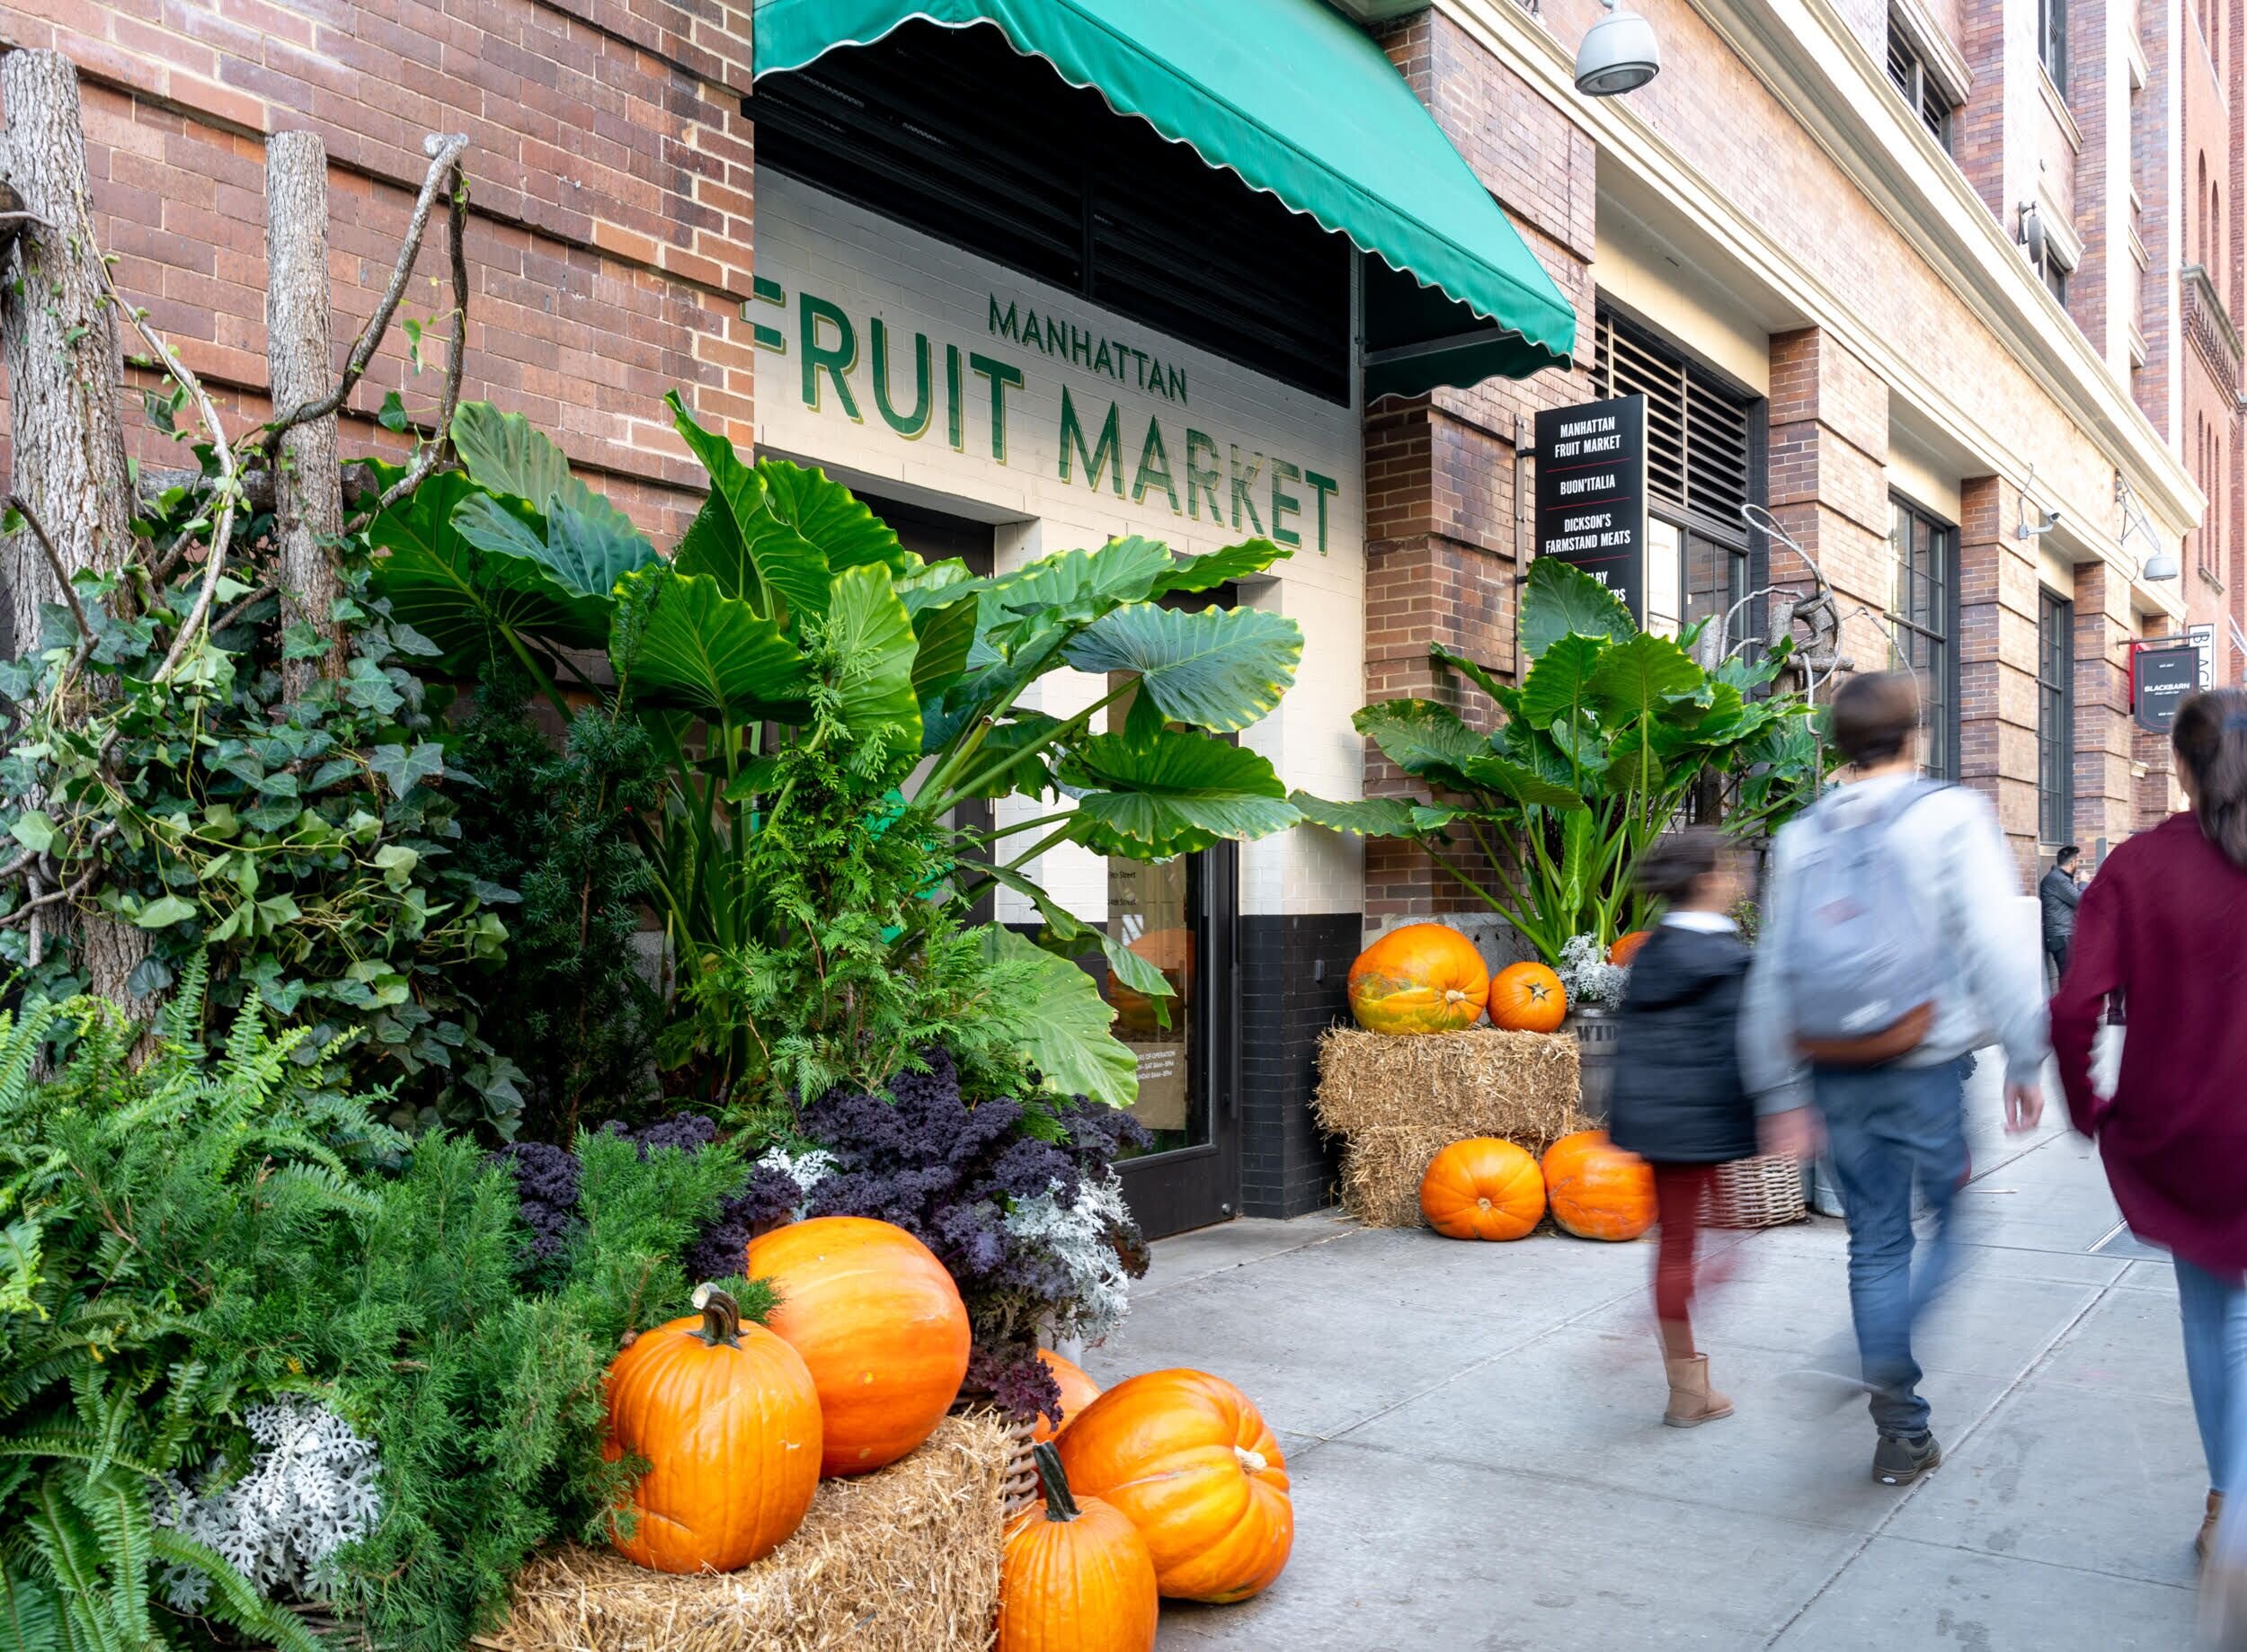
[{"left": 1088, "top": 1083, "right": 2207, "bottom": 1652}]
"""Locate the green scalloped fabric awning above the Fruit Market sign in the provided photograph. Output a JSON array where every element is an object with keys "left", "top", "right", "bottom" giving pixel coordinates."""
[{"left": 755, "top": 0, "right": 1576, "bottom": 400}]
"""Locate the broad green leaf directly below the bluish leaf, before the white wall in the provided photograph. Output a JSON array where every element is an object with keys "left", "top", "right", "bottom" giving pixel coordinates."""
[{"left": 1061, "top": 731, "right": 1301, "bottom": 861}]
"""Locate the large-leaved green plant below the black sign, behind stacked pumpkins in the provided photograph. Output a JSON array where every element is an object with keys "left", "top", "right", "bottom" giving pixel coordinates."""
[{"left": 1294, "top": 560, "right": 1816, "bottom": 966}]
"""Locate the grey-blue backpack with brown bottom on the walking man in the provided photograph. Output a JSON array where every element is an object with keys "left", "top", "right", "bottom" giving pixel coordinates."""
[{"left": 1773, "top": 780, "right": 1953, "bottom": 1068}]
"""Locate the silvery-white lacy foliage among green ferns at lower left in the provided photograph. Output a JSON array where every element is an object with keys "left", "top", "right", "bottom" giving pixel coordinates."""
[{"left": 155, "top": 1400, "right": 382, "bottom": 1612}]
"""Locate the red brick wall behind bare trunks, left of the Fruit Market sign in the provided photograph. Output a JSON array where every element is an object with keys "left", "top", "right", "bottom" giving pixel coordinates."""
[{"left": 0, "top": 0, "right": 755, "bottom": 530}]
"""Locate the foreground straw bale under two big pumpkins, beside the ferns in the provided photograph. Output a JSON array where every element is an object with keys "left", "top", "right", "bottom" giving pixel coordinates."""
[{"left": 501, "top": 1411, "right": 1014, "bottom": 1652}]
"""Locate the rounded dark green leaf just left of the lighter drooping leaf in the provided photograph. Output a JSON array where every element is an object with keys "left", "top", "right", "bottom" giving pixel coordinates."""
[{"left": 609, "top": 566, "right": 818, "bottom": 722}]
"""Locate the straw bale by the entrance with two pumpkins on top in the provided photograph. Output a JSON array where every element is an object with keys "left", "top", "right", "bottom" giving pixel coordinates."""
[{"left": 1312, "top": 1027, "right": 1586, "bottom": 1227}]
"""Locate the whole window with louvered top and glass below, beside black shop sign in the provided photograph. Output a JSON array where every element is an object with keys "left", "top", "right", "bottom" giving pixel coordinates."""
[{"left": 1591, "top": 306, "right": 1764, "bottom": 643}]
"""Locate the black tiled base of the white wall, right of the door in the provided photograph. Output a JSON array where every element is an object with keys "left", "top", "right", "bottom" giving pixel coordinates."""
[{"left": 1240, "top": 912, "right": 1364, "bottom": 1216}]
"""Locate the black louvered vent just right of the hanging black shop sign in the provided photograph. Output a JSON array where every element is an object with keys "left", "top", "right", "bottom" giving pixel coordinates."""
[{"left": 1591, "top": 310, "right": 1755, "bottom": 539}]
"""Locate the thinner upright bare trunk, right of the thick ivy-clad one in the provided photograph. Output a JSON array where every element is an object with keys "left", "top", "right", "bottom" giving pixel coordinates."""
[{"left": 265, "top": 133, "right": 344, "bottom": 699}]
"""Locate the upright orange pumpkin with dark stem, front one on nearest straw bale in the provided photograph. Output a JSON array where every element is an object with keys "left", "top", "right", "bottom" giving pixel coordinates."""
[{"left": 602, "top": 1285, "right": 821, "bottom": 1571}]
